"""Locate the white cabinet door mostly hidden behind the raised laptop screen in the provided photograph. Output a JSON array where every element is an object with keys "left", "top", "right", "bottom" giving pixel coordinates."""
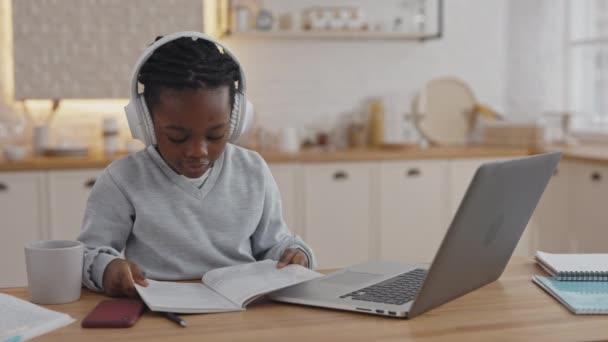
[{"left": 448, "top": 158, "right": 535, "bottom": 256}]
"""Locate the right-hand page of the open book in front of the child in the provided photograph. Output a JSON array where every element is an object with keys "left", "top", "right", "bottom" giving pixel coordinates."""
[{"left": 203, "top": 260, "right": 322, "bottom": 306}]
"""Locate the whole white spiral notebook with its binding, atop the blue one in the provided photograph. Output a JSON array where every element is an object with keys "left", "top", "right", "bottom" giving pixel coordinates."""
[{"left": 536, "top": 251, "right": 608, "bottom": 281}]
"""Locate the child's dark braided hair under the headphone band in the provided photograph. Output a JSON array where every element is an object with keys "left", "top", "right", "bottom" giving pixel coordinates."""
[{"left": 137, "top": 37, "right": 240, "bottom": 113}]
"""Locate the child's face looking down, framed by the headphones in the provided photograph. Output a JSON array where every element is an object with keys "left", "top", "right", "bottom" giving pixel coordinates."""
[{"left": 152, "top": 86, "right": 231, "bottom": 178}]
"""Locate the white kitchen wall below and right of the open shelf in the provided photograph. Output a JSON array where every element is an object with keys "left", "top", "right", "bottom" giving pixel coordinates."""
[{"left": 226, "top": 0, "right": 508, "bottom": 132}]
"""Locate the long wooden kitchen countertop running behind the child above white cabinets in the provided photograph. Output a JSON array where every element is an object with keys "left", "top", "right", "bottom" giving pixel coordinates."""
[{"left": 0, "top": 145, "right": 608, "bottom": 172}]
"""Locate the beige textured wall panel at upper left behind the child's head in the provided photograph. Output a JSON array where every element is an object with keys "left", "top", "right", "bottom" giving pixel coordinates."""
[{"left": 12, "top": 0, "right": 203, "bottom": 98}]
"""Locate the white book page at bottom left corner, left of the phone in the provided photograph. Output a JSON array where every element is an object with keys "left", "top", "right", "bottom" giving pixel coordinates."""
[{"left": 0, "top": 293, "right": 75, "bottom": 341}]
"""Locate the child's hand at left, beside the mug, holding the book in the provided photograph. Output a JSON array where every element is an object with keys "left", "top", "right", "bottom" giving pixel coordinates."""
[{"left": 103, "top": 259, "right": 148, "bottom": 298}]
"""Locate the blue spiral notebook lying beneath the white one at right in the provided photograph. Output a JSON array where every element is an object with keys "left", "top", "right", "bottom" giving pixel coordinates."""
[{"left": 532, "top": 276, "right": 608, "bottom": 315}]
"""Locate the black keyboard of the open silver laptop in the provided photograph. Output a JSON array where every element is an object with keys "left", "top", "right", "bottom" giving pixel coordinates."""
[{"left": 340, "top": 268, "right": 427, "bottom": 305}]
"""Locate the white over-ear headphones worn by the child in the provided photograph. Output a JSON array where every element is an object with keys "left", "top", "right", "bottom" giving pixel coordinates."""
[{"left": 125, "top": 31, "right": 253, "bottom": 146}]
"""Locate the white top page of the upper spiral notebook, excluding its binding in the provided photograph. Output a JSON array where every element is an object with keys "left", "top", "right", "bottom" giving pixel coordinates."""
[{"left": 536, "top": 251, "right": 608, "bottom": 272}]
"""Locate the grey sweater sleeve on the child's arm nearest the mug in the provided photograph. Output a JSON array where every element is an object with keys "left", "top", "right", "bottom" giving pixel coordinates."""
[{"left": 78, "top": 168, "right": 135, "bottom": 291}]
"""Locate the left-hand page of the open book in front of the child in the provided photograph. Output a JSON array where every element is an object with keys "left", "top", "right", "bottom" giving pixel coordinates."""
[{"left": 135, "top": 279, "right": 241, "bottom": 313}]
